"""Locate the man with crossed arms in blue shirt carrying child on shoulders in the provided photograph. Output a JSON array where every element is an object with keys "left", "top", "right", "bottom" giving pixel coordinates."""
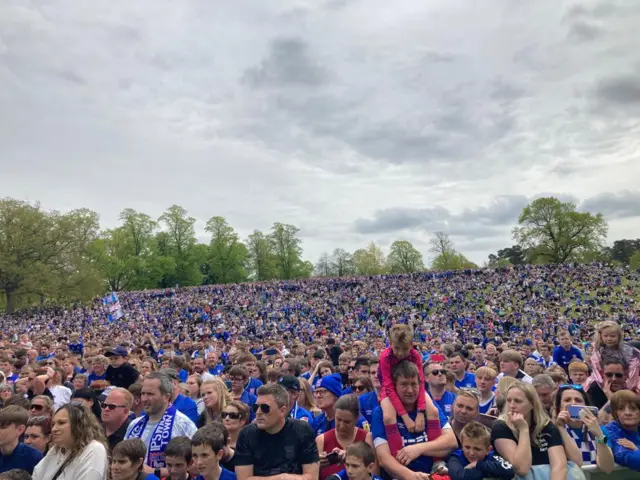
[{"left": 372, "top": 360, "right": 457, "bottom": 480}]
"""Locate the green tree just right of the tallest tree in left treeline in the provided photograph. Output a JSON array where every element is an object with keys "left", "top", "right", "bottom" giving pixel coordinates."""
[{"left": 205, "top": 217, "right": 248, "bottom": 283}]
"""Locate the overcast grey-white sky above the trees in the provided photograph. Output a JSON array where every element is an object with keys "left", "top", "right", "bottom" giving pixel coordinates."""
[{"left": 0, "top": 0, "right": 640, "bottom": 262}]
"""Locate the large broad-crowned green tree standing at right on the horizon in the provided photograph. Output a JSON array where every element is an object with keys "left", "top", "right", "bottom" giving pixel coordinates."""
[{"left": 513, "top": 197, "right": 608, "bottom": 263}]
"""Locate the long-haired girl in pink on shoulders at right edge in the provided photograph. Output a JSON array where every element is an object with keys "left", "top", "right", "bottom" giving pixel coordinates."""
[{"left": 584, "top": 321, "right": 640, "bottom": 394}]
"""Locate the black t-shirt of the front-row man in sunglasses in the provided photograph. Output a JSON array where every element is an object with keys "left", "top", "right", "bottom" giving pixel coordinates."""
[{"left": 234, "top": 418, "right": 320, "bottom": 477}]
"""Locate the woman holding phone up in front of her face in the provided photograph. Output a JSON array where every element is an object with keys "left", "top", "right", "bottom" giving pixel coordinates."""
[{"left": 555, "top": 385, "right": 614, "bottom": 473}]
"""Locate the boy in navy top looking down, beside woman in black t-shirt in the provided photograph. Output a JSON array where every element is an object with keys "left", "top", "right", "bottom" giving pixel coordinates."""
[{"left": 447, "top": 422, "right": 515, "bottom": 480}]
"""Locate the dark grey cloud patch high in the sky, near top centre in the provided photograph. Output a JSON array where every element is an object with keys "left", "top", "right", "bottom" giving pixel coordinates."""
[{"left": 243, "top": 38, "right": 328, "bottom": 88}]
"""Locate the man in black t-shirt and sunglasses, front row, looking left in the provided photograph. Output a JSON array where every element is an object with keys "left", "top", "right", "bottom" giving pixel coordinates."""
[{"left": 234, "top": 384, "right": 320, "bottom": 480}]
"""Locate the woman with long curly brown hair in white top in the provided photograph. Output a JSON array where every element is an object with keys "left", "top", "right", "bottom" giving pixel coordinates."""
[{"left": 33, "top": 403, "right": 109, "bottom": 480}]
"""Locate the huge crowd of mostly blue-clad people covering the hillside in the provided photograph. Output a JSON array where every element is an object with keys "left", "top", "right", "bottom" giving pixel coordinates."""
[{"left": 0, "top": 264, "right": 640, "bottom": 480}]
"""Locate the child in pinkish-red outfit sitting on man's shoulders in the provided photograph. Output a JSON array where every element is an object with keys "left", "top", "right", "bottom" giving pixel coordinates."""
[{"left": 378, "top": 324, "right": 442, "bottom": 457}]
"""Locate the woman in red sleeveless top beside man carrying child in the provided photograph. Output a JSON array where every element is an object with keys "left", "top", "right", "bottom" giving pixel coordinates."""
[{"left": 316, "top": 394, "right": 373, "bottom": 480}]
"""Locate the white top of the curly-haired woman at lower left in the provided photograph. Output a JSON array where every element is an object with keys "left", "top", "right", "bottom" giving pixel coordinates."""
[{"left": 33, "top": 440, "right": 109, "bottom": 480}]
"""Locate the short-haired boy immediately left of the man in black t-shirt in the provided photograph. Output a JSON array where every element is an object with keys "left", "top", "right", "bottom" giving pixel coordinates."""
[{"left": 191, "top": 426, "right": 236, "bottom": 480}]
